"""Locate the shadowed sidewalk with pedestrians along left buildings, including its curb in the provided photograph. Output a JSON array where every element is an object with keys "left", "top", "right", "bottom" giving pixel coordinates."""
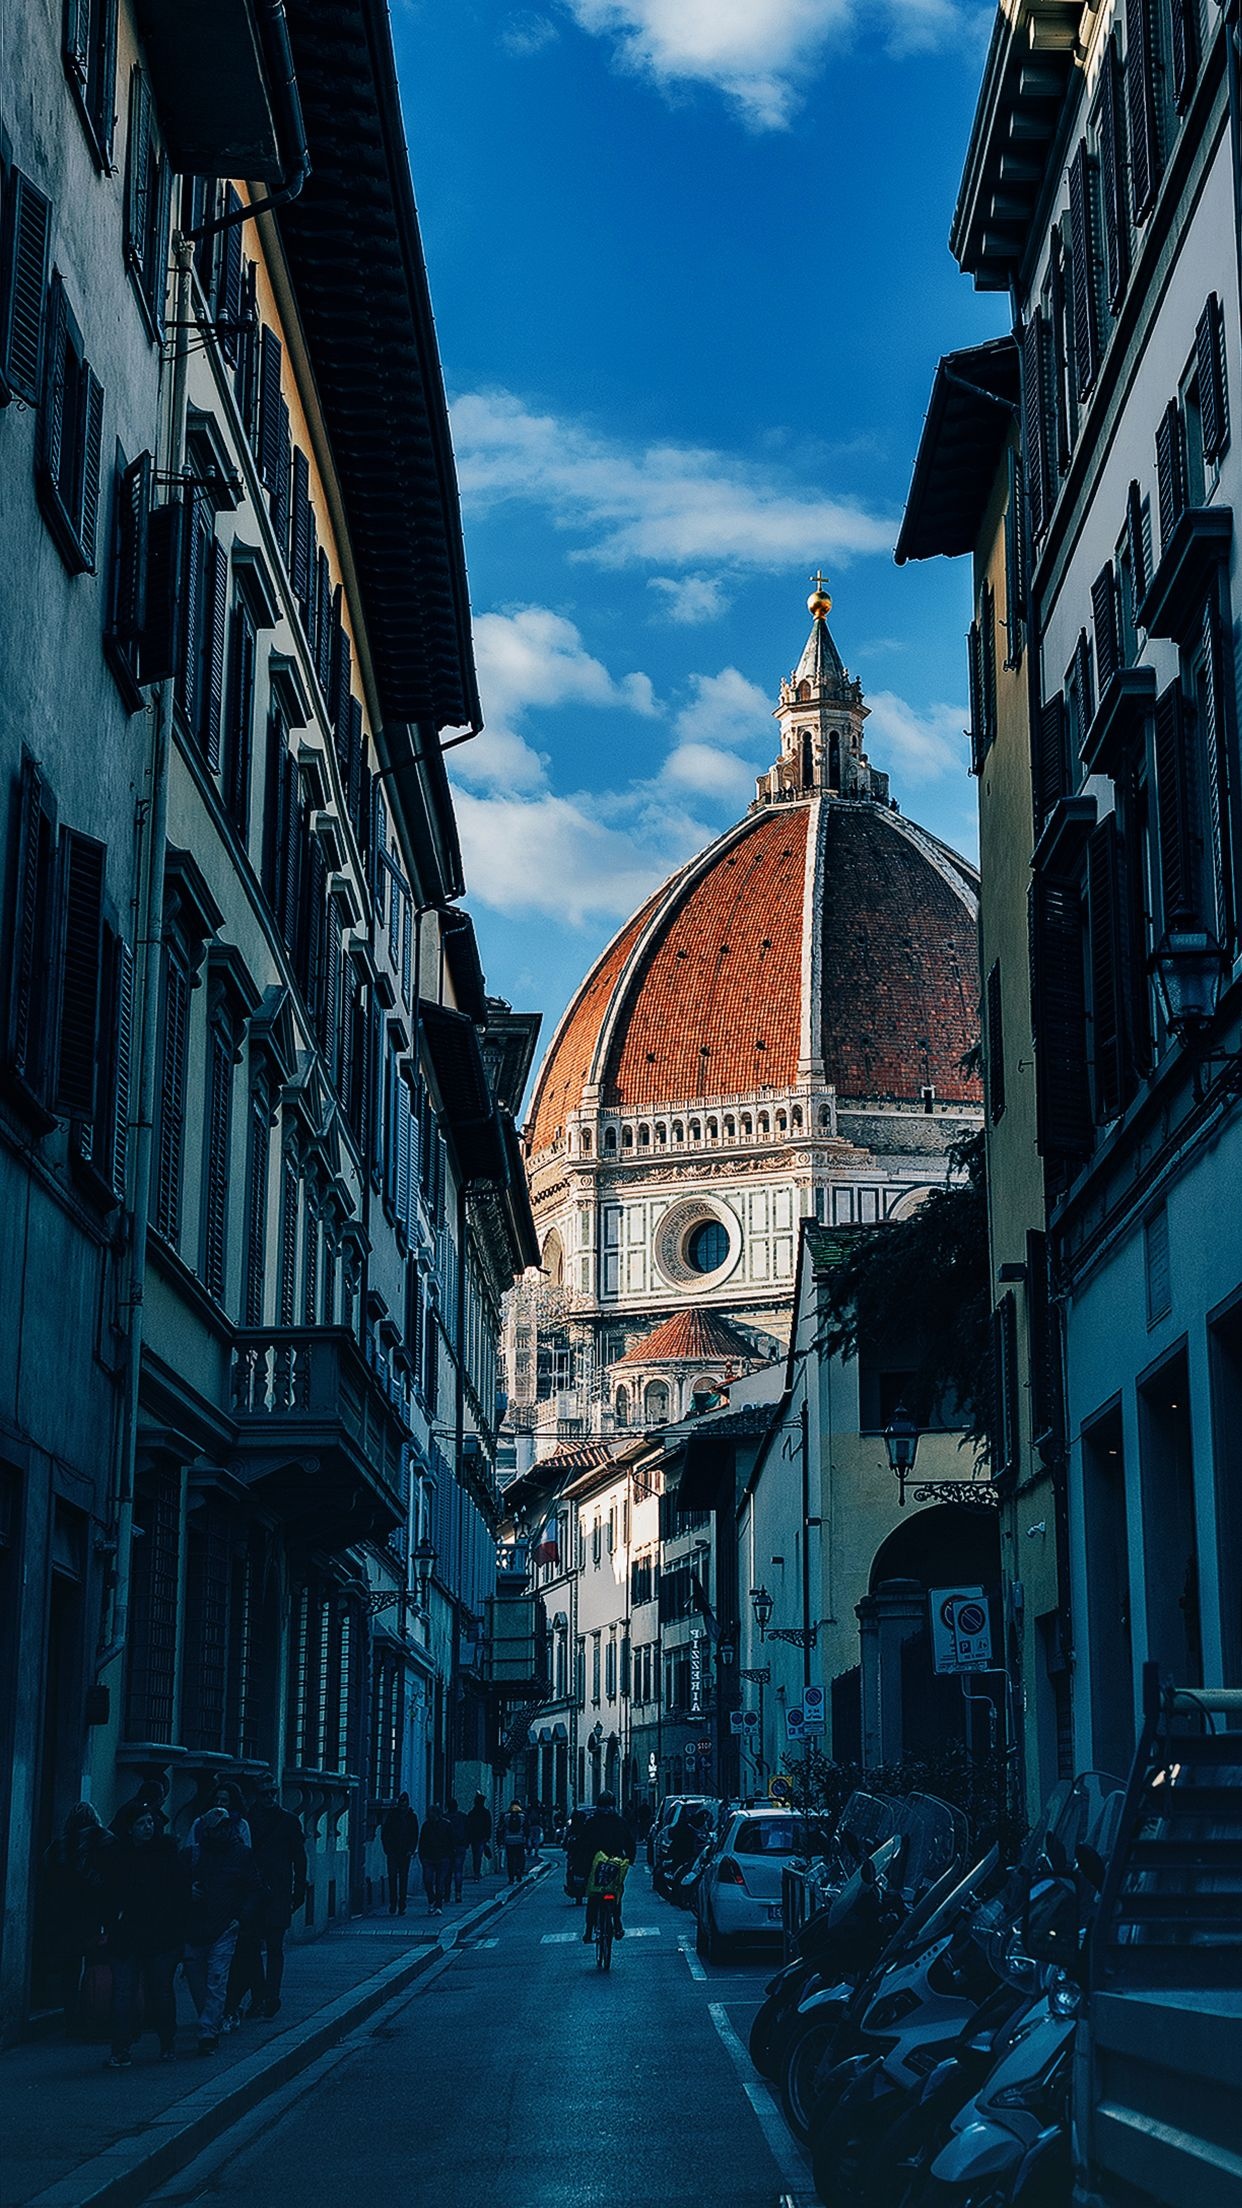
[{"left": 0, "top": 1872, "right": 537, "bottom": 2208}]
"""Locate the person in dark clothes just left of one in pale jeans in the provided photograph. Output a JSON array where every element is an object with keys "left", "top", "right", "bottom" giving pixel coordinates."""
[{"left": 104, "top": 1795, "right": 190, "bottom": 2069}]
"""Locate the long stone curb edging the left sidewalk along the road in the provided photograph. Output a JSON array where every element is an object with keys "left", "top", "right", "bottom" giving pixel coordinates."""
[{"left": 24, "top": 1864, "right": 550, "bottom": 2208}]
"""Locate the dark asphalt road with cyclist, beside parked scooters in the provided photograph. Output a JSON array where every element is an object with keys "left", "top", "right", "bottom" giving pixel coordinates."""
[{"left": 159, "top": 1857, "right": 811, "bottom": 2208}]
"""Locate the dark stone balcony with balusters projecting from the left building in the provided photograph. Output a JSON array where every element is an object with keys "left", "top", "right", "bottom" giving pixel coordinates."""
[{"left": 230, "top": 1327, "right": 409, "bottom": 1548}]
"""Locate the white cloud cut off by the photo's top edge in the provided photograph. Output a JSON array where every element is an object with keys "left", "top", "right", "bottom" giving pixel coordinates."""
[{"left": 556, "top": 0, "right": 961, "bottom": 130}]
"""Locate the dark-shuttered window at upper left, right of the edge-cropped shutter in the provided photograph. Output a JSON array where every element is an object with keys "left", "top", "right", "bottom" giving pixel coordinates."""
[{"left": 35, "top": 274, "right": 104, "bottom": 574}]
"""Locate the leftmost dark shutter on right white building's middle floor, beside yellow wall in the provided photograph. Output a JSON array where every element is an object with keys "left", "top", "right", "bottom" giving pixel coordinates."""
[{"left": 1032, "top": 874, "right": 1092, "bottom": 1157}]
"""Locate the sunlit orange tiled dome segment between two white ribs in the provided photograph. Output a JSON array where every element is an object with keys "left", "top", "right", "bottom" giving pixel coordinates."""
[{"left": 603, "top": 806, "right": 809, "bottom": 1111}]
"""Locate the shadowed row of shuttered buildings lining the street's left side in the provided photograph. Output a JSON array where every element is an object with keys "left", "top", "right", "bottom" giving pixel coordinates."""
[{"left": 0, "top": 0, "right": 537, "bottom": 2027}]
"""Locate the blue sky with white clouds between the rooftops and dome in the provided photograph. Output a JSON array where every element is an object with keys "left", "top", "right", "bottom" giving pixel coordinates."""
[{"left": 396, "top": 0, "right": 1003, "bottom": 1042}]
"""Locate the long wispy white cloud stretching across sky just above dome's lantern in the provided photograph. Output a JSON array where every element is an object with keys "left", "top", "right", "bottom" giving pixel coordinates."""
[{"left": 453, "top": 391, "right": 895, "bottom": 574}]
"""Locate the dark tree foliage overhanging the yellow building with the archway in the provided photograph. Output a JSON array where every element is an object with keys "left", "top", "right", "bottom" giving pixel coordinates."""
[{"left": 822, "top": 1130, "right": 992, "bottom": 1455}]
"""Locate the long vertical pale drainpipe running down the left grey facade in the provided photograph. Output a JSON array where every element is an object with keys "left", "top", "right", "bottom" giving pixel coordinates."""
[{"left": 95, "top": 236, "right": 194, "bottom": 1680}]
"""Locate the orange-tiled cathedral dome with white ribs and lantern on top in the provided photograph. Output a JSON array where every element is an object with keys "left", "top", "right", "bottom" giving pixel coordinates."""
[{"left": 528, "top": 592, "right": 979, "bottom": 1159}]
